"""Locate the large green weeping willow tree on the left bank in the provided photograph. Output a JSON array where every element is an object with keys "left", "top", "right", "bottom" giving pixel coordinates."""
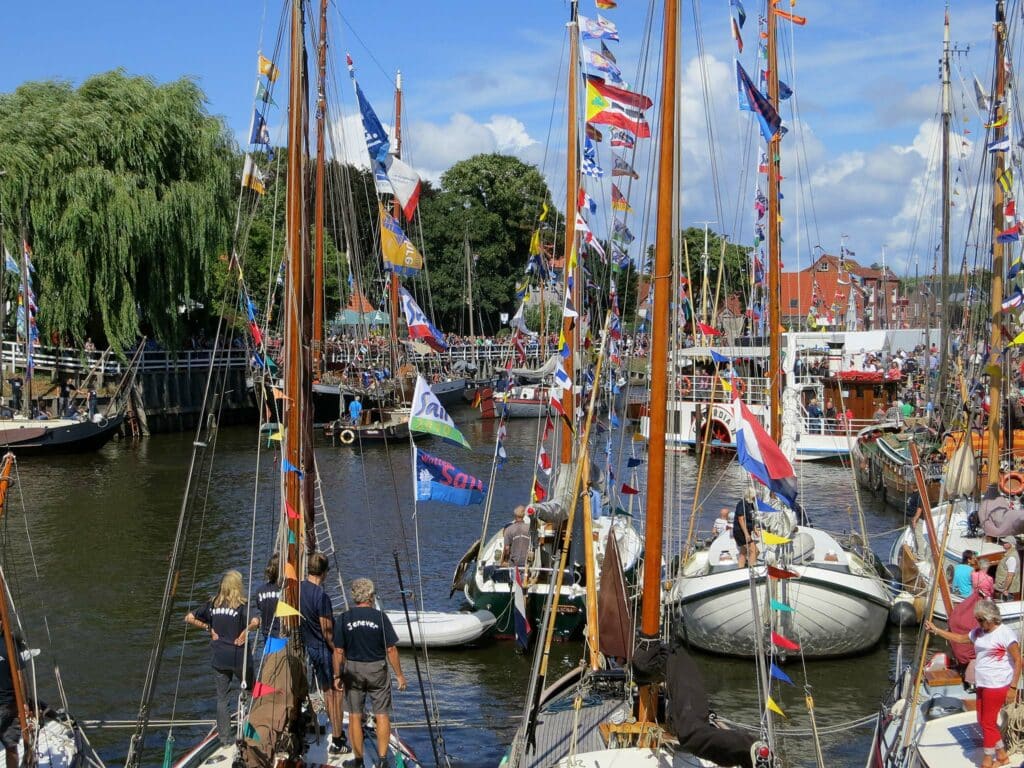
[{"left": 0, "top": 71, "right": 237, "bottom": 348}]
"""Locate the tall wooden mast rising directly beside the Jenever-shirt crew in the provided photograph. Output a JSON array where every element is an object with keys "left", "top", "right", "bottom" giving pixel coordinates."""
[{"left": 281, "top": 0, "right": 312, "bottom": 631}]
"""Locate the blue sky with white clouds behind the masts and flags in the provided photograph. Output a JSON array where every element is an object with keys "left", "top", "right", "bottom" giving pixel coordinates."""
[{"left": 0, "top": 0, "right": 1007, "bottom": 274}]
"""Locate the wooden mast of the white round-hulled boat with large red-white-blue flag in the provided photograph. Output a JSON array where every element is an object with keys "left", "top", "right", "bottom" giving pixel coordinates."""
[{"left": 766, "top": 0, "right": 782, "bottom": 442}]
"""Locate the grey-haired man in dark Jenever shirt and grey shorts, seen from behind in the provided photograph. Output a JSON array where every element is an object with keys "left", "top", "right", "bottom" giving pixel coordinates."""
[{"left": 337, "top": 579, "right": 408, "bottom": 768}]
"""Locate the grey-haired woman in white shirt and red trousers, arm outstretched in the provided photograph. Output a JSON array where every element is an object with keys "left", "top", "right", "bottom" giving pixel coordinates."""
[{"left": 925, "top": 600, "right": 1021, "bottom": 768}]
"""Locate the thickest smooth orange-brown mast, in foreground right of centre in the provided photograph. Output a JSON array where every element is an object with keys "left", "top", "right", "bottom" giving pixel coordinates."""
[{"left": 639, "top": 0, "right": 679, "bottom": 722}]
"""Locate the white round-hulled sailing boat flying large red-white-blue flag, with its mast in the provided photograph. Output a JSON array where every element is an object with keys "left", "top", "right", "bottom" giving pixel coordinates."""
[{"left": 667, "top": 3, "right": 891, "bottom": 657}]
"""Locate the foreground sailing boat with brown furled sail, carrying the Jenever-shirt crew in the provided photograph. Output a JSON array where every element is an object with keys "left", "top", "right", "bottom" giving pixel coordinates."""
[{"left": 126, "top": 0, "right": 418, "bottom": 768}]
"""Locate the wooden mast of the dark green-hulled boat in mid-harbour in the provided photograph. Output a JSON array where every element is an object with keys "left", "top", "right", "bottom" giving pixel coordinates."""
[{"left": 561, "top": 0, "right": 580, "bottom": 462}]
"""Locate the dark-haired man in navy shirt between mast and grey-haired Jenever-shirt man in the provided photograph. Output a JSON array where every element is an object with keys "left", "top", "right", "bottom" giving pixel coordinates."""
[{"left": 299, "top": 552, "right": 348, "bottom": 755}]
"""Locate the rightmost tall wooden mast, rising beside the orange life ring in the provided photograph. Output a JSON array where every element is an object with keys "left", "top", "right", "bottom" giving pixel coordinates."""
[{"left": 988, "top": 0, "right": 1007, "bottom": 485}]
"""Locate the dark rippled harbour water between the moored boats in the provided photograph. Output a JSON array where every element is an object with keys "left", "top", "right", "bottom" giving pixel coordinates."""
[{"left": 0, "top": 411, "right": 913, "bottom": 767}]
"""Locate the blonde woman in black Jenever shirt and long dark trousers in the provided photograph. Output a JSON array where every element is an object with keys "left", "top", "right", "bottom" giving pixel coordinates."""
[{"left": 185, "top": 570, "right": 259, "bottom": 746}]
